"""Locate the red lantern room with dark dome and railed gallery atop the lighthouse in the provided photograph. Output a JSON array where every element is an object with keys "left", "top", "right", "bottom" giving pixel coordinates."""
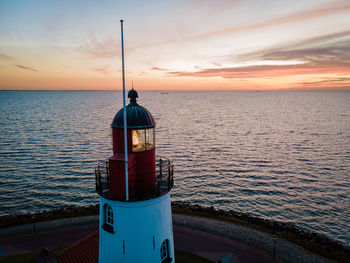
[{"left": 96, "top": 89, "right": 173, "bottom": 201}]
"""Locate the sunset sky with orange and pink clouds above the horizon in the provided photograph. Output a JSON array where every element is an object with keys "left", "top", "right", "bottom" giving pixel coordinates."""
[{"left": 0, "top": 0, "right": 350, "bottom": 90}]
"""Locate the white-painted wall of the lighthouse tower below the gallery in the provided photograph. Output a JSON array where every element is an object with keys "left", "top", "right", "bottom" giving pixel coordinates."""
[{"left": 99, "top": 192, "right": 175, "bottom": 263}]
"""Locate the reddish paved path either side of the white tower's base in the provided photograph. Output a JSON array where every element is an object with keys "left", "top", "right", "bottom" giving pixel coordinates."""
[{"left": 0, "top": 223, "right": 275, "bottom": 263}]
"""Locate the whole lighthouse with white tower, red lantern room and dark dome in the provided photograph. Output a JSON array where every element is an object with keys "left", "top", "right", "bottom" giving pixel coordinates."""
[{"left": 95, "top": 89, "right": 175, "bottom": 263}]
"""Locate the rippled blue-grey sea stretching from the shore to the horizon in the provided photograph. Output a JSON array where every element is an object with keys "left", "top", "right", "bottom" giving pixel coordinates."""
[{"left": 0, "top": 90, "right": 350, "bottom": 247}]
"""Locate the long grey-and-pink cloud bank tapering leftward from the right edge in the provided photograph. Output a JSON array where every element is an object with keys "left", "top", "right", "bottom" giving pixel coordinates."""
[{"left": 168, "top": 31, "right": 350, "bottom": 79}]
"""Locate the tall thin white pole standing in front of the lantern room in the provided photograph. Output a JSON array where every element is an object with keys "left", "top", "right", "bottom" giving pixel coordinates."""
[{"left": 120, "top": 20, "right": 129, "bottom": 201}]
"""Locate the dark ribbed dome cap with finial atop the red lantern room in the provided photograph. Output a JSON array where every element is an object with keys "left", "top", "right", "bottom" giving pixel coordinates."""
[{"left": 112, "top": 89, "right": 156, "bottom": 129}]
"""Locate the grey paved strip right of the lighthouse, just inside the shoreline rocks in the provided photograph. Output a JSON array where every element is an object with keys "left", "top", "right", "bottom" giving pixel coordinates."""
[{"left": 173, "top": 214, "right": 334, "bottom": 263}]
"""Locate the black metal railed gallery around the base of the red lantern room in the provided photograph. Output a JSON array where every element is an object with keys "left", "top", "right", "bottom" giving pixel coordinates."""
[{"left": 95, "top": 157, "right": 174, "bottom": 201}]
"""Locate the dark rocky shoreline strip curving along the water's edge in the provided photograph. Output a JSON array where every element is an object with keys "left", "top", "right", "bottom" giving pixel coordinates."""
[{"left": 0, "top": 202, "right": 350, "bottom": 262}]
